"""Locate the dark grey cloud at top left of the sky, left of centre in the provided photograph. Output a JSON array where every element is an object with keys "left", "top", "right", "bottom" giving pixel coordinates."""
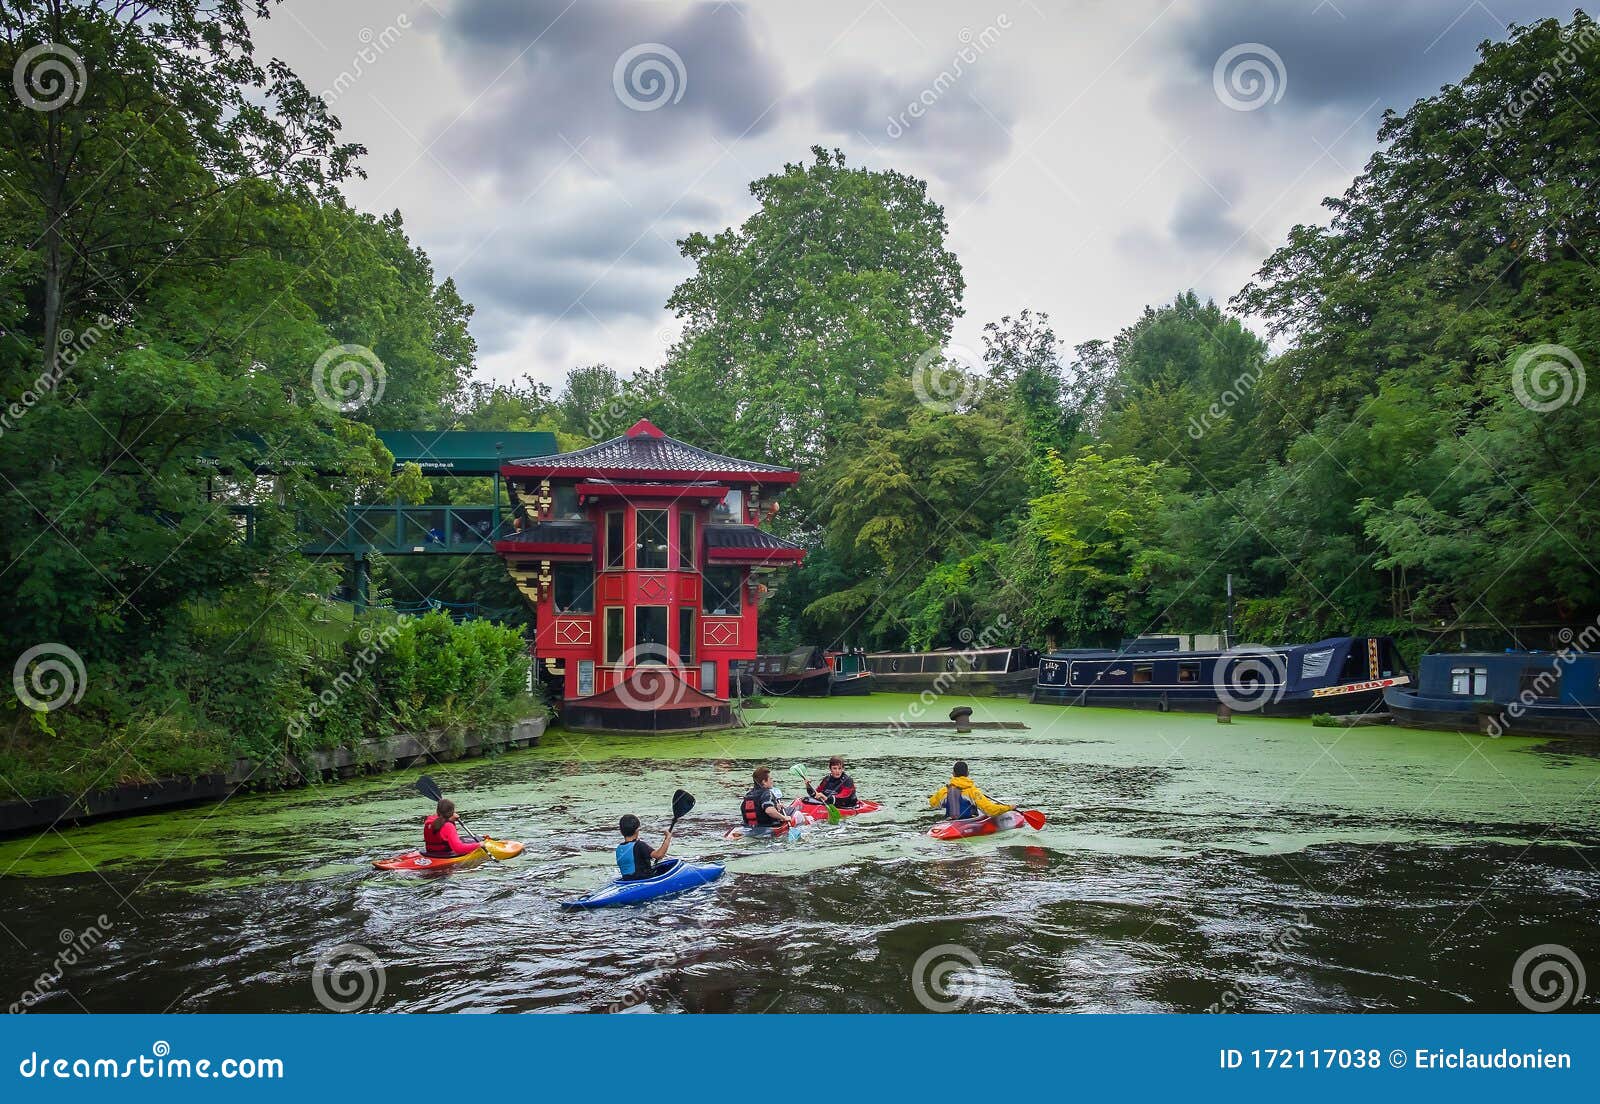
[{"left": 438, "top": 0, "right": 782, "bottom": 178}]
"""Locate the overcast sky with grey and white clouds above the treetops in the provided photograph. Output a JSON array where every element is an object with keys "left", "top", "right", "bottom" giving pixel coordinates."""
[{"left": 258, "top": 0, "right": 1573, "bottom": 384}]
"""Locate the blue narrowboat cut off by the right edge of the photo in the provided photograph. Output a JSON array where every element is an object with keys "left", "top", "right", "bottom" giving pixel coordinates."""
[{"left": 1384, "top": 650, "right": 1600, "bottom": 736}]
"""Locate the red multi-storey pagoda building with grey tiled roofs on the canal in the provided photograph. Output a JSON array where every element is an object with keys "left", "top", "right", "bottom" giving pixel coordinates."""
[{"left": 494, "top": 419, "right": 805, "bottom": 733}]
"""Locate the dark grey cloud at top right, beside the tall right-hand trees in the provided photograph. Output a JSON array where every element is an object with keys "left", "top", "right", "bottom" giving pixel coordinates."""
[{"left": 1168, "top": 0, "right": 1573, "bottom": 112}]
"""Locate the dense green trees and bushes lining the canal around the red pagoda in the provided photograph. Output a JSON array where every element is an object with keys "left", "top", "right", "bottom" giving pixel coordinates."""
[{"left": 0, "top": 0, "right": 1600, "bottom": 794}]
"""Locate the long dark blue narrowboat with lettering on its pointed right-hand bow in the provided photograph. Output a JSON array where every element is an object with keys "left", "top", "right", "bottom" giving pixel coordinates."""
[{"left": 1034, "top": 637, "right": 1411, "bottom": 717}]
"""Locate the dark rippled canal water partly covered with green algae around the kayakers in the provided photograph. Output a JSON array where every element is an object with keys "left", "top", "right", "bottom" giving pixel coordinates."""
[{"left": 0, "top": 694, "right": 1600, "bottom": 1011}]
